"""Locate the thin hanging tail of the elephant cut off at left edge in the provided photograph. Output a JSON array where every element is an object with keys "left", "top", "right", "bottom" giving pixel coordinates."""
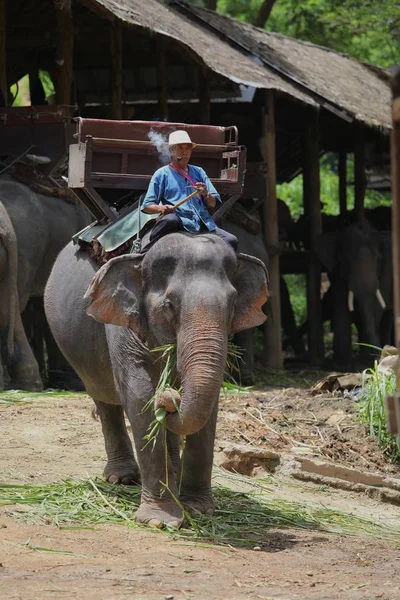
[{"left": 1, "top": 207, "right": 19, "bottom": 359}]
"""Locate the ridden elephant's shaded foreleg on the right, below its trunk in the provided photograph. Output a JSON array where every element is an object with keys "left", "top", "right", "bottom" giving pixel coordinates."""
[{"left": 180, "top": 405, "right": 218, "bottom": 515}]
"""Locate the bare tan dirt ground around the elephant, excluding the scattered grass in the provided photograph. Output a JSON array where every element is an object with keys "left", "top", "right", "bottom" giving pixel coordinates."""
[{"left": 0, "top": 377, "right": 400, "bottom": 600}]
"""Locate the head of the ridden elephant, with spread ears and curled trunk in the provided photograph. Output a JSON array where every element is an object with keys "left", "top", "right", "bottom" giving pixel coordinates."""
[{"left": 81, "top": 233, "right": 268, "bottom": 435}]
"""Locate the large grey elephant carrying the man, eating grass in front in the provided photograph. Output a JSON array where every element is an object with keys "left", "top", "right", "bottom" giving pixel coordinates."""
[{"left": 44, "top": 232, "right": 268, "bottom": 527}]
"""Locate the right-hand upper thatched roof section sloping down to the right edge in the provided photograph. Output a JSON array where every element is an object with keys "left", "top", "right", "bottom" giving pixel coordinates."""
[{"left": 177, "top": 2, "right": 391, "bottom": 129}]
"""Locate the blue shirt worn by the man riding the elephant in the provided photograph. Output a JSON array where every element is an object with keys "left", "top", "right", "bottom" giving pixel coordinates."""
[{"left": 142, "top": 165, "right": 221, "bottom": 233}]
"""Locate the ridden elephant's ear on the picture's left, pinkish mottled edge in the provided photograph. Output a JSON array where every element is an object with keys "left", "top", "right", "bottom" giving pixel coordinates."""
[{"left": 84, "top": 254, "right": 144, "bottom": 334}]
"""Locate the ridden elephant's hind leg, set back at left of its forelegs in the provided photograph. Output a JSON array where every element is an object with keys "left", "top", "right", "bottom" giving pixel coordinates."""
[{"left": 94, "top": 400, "right": 140, "bottom": 485}]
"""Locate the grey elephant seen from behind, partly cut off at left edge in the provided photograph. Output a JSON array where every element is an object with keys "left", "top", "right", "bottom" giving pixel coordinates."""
[{"left": 0, "top": 174, "right": 91, "bottom": 390}]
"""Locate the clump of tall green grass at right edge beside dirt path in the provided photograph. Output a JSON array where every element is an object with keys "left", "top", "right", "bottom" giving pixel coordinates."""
[{"left": 358, "top": 362, "right": 400, "bottom": 462}]
